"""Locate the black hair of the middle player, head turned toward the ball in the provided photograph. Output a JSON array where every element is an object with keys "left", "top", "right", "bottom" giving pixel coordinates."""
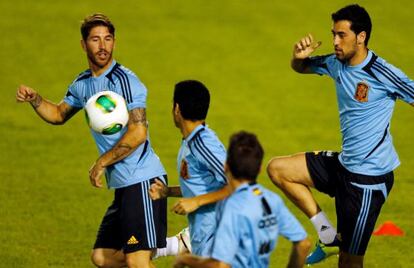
[{"left": 173, "top": 80, "right": 210, "bottom": 121}]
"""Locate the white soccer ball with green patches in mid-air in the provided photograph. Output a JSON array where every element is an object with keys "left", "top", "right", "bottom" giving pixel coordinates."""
[{"left": 85, "top": 90, "right": 128, "bottom": 135}]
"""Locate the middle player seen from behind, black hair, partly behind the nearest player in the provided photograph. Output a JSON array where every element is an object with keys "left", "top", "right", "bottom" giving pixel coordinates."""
[{"left": 150, "top": 80, "right": 229, "bottom": 256}]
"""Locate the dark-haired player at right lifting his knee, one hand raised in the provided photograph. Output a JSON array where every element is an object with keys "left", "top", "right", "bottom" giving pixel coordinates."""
[{"left": 268, "top": 5, "right": 414, "bottom": 267}]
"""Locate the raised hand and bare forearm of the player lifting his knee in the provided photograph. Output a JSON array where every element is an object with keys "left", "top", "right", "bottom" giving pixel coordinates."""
[{"left": 290, "top": 34, "right": 322, "bottom": 74}]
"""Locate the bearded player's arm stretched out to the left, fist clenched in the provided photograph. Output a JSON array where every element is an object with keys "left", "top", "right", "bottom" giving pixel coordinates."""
[{"left": 16, "top": 85, "right": 79, "bottom": 125}]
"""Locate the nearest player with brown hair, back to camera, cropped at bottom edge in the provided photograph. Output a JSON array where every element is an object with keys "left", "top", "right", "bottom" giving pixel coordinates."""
[{"left": 175, "top": 131, "right": 310, "bottom": 268}]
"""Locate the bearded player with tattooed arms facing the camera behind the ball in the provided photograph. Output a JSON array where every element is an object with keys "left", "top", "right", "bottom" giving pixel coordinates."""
[{"left": 16, "top": 14, "right": 178, "bottom": 268}]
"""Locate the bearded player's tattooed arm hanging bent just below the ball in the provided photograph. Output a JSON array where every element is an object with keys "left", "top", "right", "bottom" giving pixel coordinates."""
[{"left": 89, "top": 108, "right": 147, "bottom": 188}]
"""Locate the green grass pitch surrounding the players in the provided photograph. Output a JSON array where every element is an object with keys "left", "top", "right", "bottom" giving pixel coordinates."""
[{"left": 0, "top": 0, "right": 414, "bottom": 267}]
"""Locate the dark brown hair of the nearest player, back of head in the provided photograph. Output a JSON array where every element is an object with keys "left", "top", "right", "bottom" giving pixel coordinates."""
[{"left": 227, "top": 131, "right": 264, "bottom": 182}]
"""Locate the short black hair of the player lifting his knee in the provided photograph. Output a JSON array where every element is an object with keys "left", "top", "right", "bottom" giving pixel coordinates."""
[{"left": 332, "top": 4, "right": 372, "bottom": 46}]
